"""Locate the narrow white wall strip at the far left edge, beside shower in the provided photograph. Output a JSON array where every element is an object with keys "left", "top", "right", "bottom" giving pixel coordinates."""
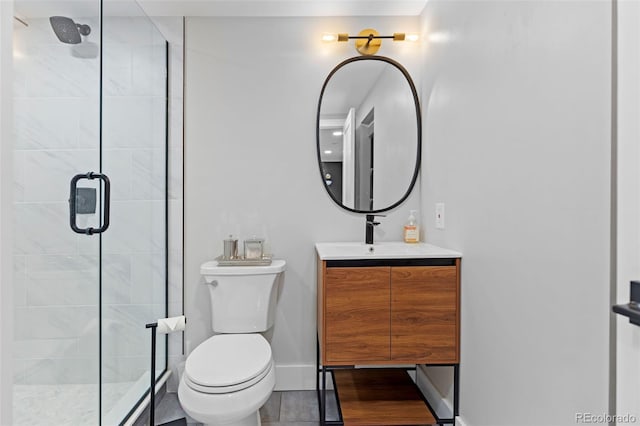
[{"left": 0, "top": 1, "right": 13, "bottom": 425}]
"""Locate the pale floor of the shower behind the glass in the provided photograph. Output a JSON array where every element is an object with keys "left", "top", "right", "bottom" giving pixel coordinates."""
[{"left": 13, "top": 382, "right": 137, "bottom": 426}]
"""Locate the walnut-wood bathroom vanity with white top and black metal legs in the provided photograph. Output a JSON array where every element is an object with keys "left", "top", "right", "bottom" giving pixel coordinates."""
[{"left": 316, "top": 242, "right": 462, "bottom": 425}]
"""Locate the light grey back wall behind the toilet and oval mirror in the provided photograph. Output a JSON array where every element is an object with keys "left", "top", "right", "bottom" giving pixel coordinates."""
[{"left": 185, "top": 17, "right": 420, "bottom": 389}]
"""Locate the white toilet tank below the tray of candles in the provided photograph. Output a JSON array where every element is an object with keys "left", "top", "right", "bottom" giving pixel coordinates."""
[{"left": 200, "top": 259, "right": 286, "bottom": 333}]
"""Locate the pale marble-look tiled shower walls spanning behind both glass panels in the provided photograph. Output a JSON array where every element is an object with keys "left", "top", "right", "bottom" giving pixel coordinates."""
[{"left": 14, "top": 18, "right": 182, "bottom": 384}]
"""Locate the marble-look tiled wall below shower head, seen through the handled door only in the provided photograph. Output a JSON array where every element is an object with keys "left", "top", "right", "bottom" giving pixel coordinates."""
[{"left": 14, "top": 19, "right": 100, "bottom": 384}]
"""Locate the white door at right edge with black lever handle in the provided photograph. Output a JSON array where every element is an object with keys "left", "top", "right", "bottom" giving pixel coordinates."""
[{"left": 616, "top": 1, "right": 640, "bottom": 419}]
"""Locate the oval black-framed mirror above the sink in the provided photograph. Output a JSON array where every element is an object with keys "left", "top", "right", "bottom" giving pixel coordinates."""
[{"left": 316, "top": 56, "right": 422, "bottom": 213}]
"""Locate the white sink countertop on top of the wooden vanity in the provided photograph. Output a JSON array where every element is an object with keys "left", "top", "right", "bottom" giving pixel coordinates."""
[{"left": 316, "top": 241, "right": 462, "bottom": 260}]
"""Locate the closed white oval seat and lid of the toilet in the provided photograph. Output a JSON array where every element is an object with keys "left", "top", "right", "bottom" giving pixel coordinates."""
[{"left": 184, "top": 334, "right": 273, "bottom": 394}]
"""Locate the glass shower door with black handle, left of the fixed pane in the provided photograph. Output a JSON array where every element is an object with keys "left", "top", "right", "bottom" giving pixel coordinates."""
[{"left": 13, "top": 0, "right": 101, "bottom": 425}]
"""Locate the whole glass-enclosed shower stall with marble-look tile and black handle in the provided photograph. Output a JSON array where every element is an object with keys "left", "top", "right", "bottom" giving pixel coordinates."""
[{"left": 13, "top": 0, "right": 168, "bottom": 425}]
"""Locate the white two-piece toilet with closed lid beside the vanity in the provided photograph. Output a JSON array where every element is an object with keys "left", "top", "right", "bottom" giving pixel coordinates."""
[{"left": 178, "top": 260, "right": 286, "bottom": 426}]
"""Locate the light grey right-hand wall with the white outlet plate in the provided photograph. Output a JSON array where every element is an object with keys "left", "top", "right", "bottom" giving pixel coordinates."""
[{"left": 422, "top": 0, "right": 608, "bottom": 426}]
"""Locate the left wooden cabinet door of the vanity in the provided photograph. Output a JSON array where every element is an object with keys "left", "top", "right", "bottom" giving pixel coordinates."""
[{"left": 324, "top": 267, "right": 391, "bottom": 364}]
